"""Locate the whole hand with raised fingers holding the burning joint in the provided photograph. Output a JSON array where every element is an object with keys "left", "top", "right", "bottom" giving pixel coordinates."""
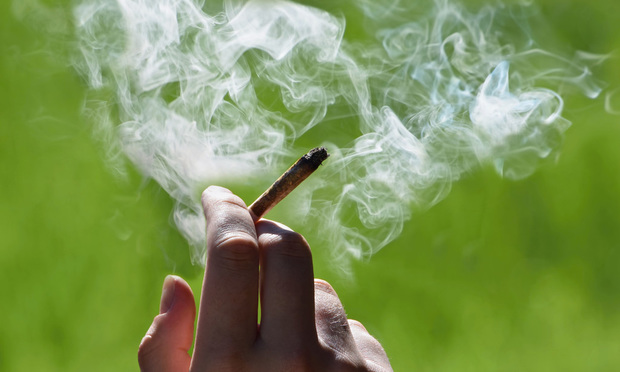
[{"left": 138, "top": 187, "right": 392, "bottom": 372}]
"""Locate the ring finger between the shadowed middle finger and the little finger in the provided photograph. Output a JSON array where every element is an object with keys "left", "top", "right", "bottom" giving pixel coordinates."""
[{"left": 314, "top": 279, "right": 360, "bottom": 360}]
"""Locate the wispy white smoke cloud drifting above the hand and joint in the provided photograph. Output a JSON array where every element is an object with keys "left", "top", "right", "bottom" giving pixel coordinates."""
[{"left": 74, "top": 0, "right": 601, "bottom": 264}]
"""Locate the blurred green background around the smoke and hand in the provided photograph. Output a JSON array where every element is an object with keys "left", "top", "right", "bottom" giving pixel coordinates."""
[{"left": 0, "top": 0, "right": 620, "bottom": 371}]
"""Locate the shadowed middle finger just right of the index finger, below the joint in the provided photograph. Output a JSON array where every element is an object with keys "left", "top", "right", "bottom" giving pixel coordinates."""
[{"left": 256, "top": 220, "right": 316, "bottom": 350}]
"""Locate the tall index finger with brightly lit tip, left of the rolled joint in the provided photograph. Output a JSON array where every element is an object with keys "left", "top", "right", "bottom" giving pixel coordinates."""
[{"left": 192, "top": 187, "right": 259, "bottom": 368}]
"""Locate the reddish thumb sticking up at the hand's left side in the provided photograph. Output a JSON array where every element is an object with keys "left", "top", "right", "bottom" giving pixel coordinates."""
[{"left": 138, "top": 275, "right": 196, "bottom": 372}]
